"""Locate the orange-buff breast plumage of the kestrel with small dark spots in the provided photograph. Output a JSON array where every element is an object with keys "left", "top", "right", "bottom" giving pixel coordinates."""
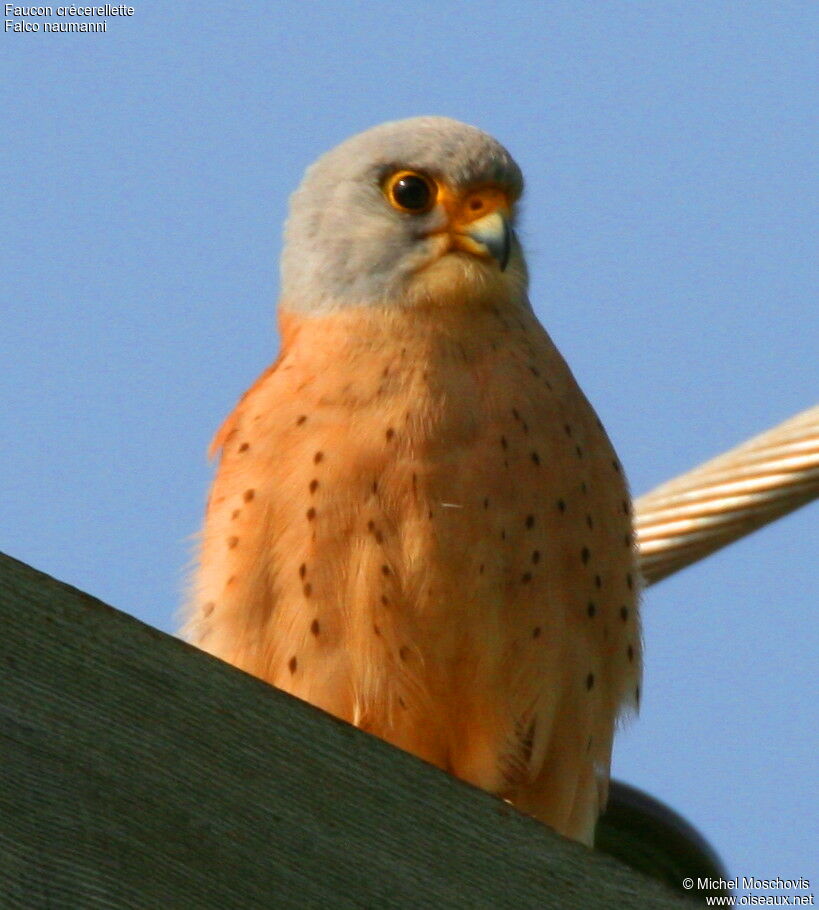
[{"left": 191, "top": 302, "right": 639, "bottom": 816}]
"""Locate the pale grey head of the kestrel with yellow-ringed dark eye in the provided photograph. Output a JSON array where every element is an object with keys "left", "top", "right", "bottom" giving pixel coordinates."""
[{"left": 282, "top": 117, "right": 527, "bottom": 313}]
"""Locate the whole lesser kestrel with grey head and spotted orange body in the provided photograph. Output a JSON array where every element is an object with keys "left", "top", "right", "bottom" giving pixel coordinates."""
[{"left": 185, "top": 117, "right": 641, "bottom": 843}]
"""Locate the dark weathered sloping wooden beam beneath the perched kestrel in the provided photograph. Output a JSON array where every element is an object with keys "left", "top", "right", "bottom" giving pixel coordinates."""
[{"left": 0, "top": 556, "right": 690, "bottom": 910}]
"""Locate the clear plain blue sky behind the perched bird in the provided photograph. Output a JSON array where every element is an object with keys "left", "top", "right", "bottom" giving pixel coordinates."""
[{"left": 0, "top": 0, "right": 819, "bottom": 887}]
